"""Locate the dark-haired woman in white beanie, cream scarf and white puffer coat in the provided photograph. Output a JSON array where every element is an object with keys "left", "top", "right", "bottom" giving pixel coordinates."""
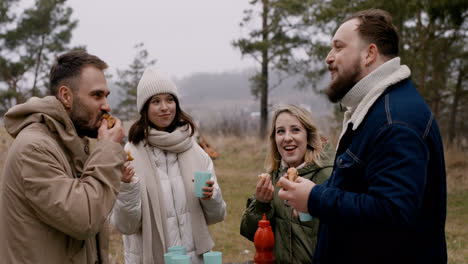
[{"left": 111, "top": 68, "right": 226, "bottom": 264}]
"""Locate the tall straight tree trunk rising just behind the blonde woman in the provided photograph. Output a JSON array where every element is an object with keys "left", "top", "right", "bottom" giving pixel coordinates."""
[{"left": 259, "top": 0, "right": 269, "bottom": 138}]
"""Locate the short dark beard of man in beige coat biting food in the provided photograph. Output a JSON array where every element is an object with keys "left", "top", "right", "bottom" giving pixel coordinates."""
[{"left": 71, "top": 96, "right": 102, "bottom": 138}]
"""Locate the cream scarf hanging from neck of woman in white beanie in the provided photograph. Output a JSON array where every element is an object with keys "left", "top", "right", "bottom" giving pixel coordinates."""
[{"left": 129, "top": 126, "right": 214, "bottom": 263}]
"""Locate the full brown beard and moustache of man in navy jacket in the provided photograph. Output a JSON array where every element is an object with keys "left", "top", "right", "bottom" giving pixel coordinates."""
[{"left": 325, "top": 60, "right": 361, "bottom": 103}]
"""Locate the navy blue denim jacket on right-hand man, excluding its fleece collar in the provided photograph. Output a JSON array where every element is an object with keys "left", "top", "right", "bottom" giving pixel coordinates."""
[{"left": 308, "top": 79, "right": 447, "bottom": 264}]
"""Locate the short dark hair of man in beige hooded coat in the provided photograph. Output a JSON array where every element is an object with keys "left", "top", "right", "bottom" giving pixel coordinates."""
[{"left": 49, "top": 50, "right": 107, "bottom": 96}]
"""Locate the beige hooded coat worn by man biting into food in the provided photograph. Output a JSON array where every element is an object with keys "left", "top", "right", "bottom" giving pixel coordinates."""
[{"left": 0, "top": 97, "right": 126, "bottom": 264}]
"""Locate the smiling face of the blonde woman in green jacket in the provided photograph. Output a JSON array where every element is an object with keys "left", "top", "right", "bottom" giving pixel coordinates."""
[{"left": 275, "top": 112, "right": 307, "bottom": 167}]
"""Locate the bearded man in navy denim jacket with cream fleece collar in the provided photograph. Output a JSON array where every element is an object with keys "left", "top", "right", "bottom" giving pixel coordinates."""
[{"left": 279, "top": 9, "right": 447, "bottom": 264}]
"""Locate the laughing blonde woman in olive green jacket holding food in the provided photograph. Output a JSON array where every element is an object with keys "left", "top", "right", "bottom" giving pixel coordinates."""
[{"left": 240, "top": 105, "right": 335, "bottom": 263}]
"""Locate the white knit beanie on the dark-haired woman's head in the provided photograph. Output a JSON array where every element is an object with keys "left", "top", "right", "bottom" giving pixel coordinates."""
[{"left": 137, "top": 68, "right": 179, "bottom": 113}]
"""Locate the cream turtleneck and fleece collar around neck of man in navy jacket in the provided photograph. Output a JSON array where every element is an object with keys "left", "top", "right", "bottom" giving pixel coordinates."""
[{"left": 337, "top": 57, "right": 411, "bottom": 142}]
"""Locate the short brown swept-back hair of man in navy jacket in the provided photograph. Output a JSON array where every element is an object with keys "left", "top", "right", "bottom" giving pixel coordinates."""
[{"left": 343, "top": 9, "right": 400, "bottom": 58}]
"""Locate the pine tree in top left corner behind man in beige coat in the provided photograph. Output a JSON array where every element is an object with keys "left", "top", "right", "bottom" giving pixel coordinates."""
[{"left": 0, "top": 0, "right": 78, "bottom": 112}]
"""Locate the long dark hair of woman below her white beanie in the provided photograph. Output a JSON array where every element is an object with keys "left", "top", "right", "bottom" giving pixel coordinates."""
[{"left": 128, "top": 96, "right": 197, "bottom": 145}]
